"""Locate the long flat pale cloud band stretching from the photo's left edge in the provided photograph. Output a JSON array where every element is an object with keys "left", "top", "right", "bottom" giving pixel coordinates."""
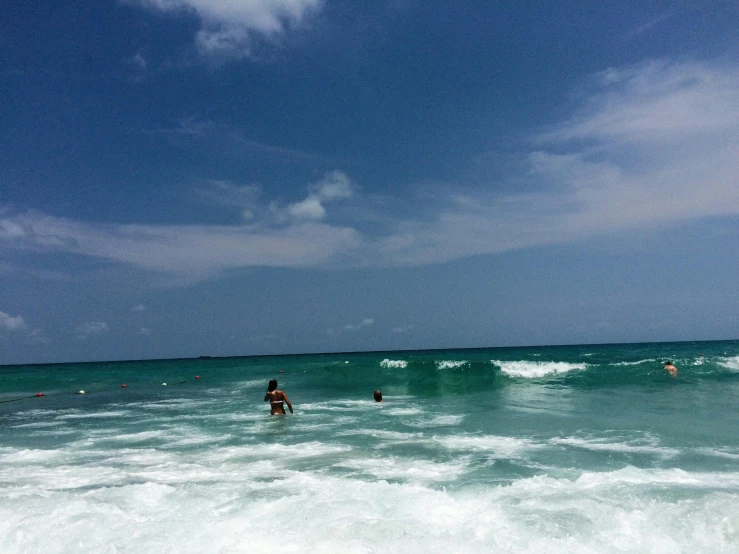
[{"left": 1, "top": 212, "right": 359, "bottom": 279}]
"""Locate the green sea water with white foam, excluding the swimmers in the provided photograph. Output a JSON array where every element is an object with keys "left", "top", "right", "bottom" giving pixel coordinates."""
[{"left": 0, "top": 341, "right": 739, "bottom": 554}]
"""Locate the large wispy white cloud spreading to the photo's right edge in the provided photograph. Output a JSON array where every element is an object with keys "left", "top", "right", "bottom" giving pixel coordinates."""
[{"left": 377, "top": 62, "right": 739, "bottom": 264}]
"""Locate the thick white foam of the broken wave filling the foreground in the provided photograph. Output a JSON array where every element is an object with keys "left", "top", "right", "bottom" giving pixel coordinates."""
[{"left": 0, "top": 458, "right": 739, "bottom": 554}]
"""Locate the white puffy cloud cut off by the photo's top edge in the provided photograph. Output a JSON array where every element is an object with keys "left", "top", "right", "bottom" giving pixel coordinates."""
[{"left": 128, "top": 0, "right": 322, "bottom": 57}]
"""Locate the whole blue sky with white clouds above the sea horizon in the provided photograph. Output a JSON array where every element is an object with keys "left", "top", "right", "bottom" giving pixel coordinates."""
[{"left": 0, "top": 0, "right": 739, "bottom": 364}]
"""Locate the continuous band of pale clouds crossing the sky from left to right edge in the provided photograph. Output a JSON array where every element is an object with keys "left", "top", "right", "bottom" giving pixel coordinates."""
[{"left": 0, "top": 60, "right": 739, "bottom": 281}]
